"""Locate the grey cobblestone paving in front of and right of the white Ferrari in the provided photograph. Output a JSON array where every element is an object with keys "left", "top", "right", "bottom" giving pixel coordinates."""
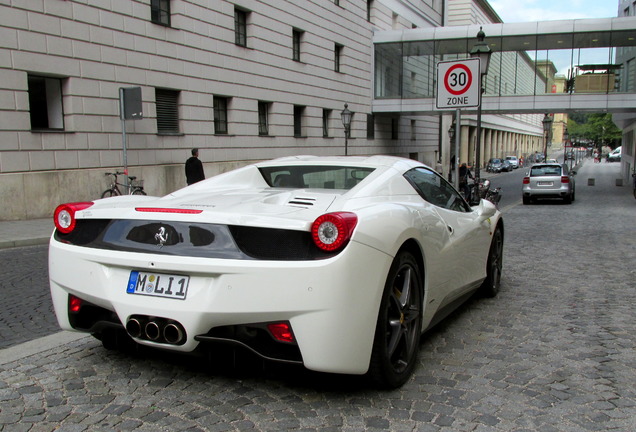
[{"left": 0, "top": 162, "right": 636, "bottom": 432}]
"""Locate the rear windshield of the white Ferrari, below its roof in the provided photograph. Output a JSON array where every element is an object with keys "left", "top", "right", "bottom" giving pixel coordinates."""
[{"left": 259, "top": 165, "right": 374, "bottom": 189}]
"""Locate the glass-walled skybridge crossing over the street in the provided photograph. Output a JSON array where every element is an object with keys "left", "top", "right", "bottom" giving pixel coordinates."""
[{"left": 373, "top": 17, "right": 636, "bottom": 114}]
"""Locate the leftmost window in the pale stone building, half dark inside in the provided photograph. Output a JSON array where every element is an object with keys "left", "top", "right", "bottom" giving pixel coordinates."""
[{"left": 27, "top": 75, "right": 64, "bottom": 130}]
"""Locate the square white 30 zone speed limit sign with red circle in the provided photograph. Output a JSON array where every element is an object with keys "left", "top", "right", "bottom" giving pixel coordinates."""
[{"left": 437, "top": 58, "right": 480, "bottom": 109}]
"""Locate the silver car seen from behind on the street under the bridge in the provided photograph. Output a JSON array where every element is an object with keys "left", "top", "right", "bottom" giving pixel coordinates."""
[{"left": 522, "top": 163, "right": 576, "bottom": 204}]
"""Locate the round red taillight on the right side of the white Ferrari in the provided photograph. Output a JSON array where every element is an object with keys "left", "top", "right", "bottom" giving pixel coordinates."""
[{"left": 311, "top": 212, "right": 358, "bottom": 252}]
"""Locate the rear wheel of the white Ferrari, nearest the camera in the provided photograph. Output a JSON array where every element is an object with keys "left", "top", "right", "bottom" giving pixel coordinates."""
[{"left": 369, "top": 251, "right": 423, "bottom": 389}]
